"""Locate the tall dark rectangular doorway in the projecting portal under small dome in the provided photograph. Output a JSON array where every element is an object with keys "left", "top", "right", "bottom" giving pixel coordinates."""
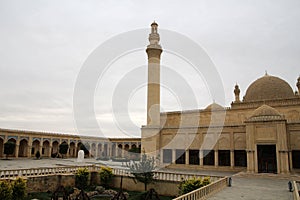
[{"left": 257, "top": 145, "right": 277, "bottom": 173}]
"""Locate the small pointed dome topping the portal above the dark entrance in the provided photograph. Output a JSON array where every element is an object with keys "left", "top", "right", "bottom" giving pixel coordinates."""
[{"left": 249, "top": 104, "right": 284, "bottom": 121}]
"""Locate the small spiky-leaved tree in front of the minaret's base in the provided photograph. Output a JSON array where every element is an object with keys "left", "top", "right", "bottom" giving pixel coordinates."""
[{"left": 127, "top": 153, "right": 156, "bottom": 191}]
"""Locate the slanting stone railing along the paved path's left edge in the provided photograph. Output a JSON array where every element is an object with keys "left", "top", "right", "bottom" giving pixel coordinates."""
[{"left": 173, "top": 177, "right": 228, "bottom": 200}]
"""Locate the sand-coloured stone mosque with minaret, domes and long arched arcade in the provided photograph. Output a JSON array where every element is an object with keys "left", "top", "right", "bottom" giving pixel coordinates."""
[{"left": 0, "top": 22, "right": 300, "bottom": 173}]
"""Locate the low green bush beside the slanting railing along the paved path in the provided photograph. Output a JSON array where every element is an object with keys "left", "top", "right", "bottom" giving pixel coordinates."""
[{"left": 178, "top": 177, "right": 211, "bottom": 195}]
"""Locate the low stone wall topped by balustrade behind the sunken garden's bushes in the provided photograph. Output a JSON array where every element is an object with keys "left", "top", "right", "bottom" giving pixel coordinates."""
[{"left": 0, "top": 165, "right": 223, "bottom": 196}]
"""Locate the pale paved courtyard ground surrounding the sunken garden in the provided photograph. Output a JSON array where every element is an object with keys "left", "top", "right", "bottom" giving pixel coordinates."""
[{"left": 0, "top": 159, "right": 300, "bottom": 200}]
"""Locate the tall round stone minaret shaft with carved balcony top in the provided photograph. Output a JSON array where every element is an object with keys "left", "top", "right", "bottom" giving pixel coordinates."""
[{"left": 146, "top": 22, "right": 162, "bottom": 126}]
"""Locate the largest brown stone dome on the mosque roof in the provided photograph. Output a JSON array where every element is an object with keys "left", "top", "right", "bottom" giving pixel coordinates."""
[{"left": 243, "top": 75, "right": 295, "bottom": 102}]
